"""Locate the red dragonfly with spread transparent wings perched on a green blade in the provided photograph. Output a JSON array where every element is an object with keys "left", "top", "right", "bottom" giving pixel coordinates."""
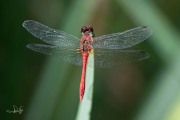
[{"left": 22, "top": 20, "right": 152, "bottom": 101}]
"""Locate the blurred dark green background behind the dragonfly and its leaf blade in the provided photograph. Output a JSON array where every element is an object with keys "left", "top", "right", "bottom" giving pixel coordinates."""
[{"left": 0, "top": 0, "right": 180, "bottom": 120}]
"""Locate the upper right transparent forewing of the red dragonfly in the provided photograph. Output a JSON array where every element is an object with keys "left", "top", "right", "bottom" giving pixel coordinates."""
[{"left": 92, "top": 26, "right": 152, "bottom": 49}]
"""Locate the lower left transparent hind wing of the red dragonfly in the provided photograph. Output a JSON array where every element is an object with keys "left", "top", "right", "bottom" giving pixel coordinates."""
[{"left": 27, "top": 44, "right": 82, "bottom": 66}]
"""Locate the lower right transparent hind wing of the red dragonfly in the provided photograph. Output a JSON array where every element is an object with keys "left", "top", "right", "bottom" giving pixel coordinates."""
[{"left": 88, "top": 50, "right": 149, "bottom": 68}]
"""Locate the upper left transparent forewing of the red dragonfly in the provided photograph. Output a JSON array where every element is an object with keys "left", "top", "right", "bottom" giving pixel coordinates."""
[{"left": 22, "top": 20, "right": 79, "bottom": 48}]
